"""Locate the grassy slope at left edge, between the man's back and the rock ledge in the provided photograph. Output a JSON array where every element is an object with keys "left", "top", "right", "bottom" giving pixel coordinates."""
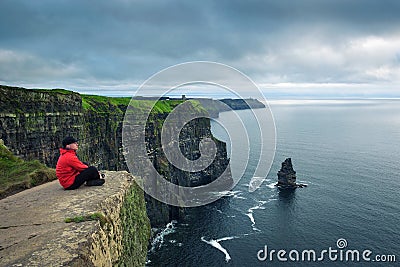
[{"left": 0, "top": 143, "right": 57, "bottom": 199}]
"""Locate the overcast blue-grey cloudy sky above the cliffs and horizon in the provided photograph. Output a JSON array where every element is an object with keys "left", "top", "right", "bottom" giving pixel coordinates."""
[{"left": 0, "top": 0, "right": 400, "bottom": 98}]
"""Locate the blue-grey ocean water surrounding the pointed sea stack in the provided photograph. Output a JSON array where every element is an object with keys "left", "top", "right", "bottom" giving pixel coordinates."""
[{"left": 147, "top": 100, "right": 400, "bottom": 266}]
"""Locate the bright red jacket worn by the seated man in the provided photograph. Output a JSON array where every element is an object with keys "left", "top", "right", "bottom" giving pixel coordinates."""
[{"left": 56, "top": 148, "right": 88, "bottom": 188}]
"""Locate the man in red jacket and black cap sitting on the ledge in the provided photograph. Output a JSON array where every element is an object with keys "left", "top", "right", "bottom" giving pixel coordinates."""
[{"left": 56, "top": 136, "right": 105, "bottom": 190}]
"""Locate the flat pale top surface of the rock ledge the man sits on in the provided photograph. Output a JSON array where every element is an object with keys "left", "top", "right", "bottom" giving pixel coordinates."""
[{"left": 0, "top": 171, "right": 133, "bottom": 266}]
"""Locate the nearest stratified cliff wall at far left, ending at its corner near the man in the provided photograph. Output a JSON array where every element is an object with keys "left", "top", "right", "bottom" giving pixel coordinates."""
[{"left": 0, "top": 86, "right": 83, "bottom": 167}]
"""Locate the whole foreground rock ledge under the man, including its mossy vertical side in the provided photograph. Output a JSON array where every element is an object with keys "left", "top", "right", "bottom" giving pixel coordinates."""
[{"left": 0, "top": 172, "right": 150, "bottom": 266}]
